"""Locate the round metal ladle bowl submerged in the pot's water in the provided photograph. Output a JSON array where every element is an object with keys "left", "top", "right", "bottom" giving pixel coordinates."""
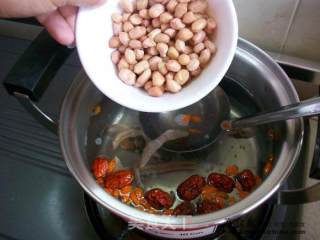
[{"left": 139, "top": 87, "right": 230, "bottom": 152}]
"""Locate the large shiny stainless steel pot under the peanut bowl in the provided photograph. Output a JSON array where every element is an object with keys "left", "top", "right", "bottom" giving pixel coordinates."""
[{"left": 6, "top": 31, "right": 320, "bottom": 239}]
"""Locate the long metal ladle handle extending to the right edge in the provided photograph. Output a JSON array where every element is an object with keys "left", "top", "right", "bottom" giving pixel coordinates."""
[{"left": 221, "top": 97, "right": 320, "bottom": 130}]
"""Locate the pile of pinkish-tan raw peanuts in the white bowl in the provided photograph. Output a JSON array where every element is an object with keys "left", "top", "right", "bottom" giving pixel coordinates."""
[{"left": 109, "top": 0, "right": 216, "bottom": 97}]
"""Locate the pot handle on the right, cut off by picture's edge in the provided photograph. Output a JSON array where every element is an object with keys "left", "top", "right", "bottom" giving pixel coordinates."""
[{"left": 277, "top": 119, "right": 320, "bottom": 205}]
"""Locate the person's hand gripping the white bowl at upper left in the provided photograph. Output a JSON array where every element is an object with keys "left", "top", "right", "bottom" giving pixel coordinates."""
[{"left": 0, "top": 0, "right": 105, "bottom": 45}]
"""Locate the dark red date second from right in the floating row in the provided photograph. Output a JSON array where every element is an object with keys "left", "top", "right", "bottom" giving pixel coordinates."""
[{"left": 208, "top": 173, "right": 235, "bottom": 193}]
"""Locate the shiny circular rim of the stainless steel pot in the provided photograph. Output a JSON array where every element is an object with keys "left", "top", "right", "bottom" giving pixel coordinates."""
[{"left": 59, "top": 39, "right": 304, "bottom": 230}]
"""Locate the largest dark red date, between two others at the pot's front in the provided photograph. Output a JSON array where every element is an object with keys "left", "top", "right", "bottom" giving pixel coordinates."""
[{"left": 177, "top": 175, "right": 206, "bottom": 201}]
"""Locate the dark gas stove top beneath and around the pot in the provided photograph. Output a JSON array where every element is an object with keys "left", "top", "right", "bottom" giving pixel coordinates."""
[{"left": 0, "top": 29, "right": 319, "bottom": 240}]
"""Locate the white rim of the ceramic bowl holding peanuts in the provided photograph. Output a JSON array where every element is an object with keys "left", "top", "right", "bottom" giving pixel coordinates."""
[{"left": 75, "top": 0, "right": 238, "bottom": 112}]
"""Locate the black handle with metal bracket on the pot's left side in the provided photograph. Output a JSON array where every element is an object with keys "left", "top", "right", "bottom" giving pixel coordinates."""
[{"left": 3, "top": 30, "right": 73, "bottom": 133}]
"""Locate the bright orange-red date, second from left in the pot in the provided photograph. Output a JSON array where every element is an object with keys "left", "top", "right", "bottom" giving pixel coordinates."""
[{"left": 104, "top": 170, "right": 134, "bottom": 189}]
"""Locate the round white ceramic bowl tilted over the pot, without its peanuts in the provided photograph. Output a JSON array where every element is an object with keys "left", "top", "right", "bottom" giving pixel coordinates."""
[{"left": 76, "top": 0, "right": 238, "bottom": 112}]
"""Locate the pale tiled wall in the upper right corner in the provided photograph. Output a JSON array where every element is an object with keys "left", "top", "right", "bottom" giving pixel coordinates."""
[{"left": 234, "top": 0, "right": 320, "bottom": 62}]
